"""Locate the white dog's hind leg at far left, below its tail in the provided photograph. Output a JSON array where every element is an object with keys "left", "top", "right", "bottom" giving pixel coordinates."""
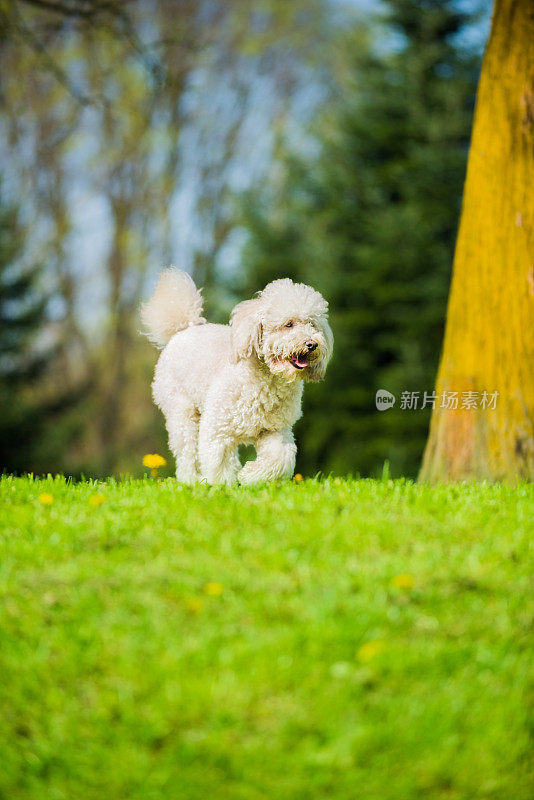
[{"left": 166, "top": 397, "right": 200, "bottom": 483}]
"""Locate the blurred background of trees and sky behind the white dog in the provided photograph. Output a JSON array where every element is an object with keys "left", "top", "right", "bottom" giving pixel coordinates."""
[{"left": 0, "top": 0, "right": 488, "bottom": 476}]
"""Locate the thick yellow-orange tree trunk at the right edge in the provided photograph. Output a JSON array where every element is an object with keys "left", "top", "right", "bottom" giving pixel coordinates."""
[{"left": 420, "top": 0, "right": 534, "bottom": 482}]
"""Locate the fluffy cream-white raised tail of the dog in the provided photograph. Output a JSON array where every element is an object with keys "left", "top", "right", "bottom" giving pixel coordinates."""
[{"left": 140, "top": 267, "right": 206, "bottom": 347}]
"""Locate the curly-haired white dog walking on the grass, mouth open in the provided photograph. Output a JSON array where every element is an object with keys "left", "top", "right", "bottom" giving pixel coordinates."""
[{"left": 141, "top": 268, "right": 333, "bottom": 484}]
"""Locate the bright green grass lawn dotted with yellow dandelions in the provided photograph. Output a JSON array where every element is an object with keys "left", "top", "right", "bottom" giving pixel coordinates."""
[{"left": 0, "top": 478, "right": 534, "bottom": 800}]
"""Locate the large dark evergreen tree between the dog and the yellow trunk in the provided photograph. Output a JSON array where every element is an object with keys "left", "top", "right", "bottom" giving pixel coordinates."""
[{"left": 242, "top": 0, "right": 479, "bottom": 475}]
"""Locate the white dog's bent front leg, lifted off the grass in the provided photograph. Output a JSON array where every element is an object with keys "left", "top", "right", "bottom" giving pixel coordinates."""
[{"left": 238, "top": 428, "right": 297, "bottom": 485}]
